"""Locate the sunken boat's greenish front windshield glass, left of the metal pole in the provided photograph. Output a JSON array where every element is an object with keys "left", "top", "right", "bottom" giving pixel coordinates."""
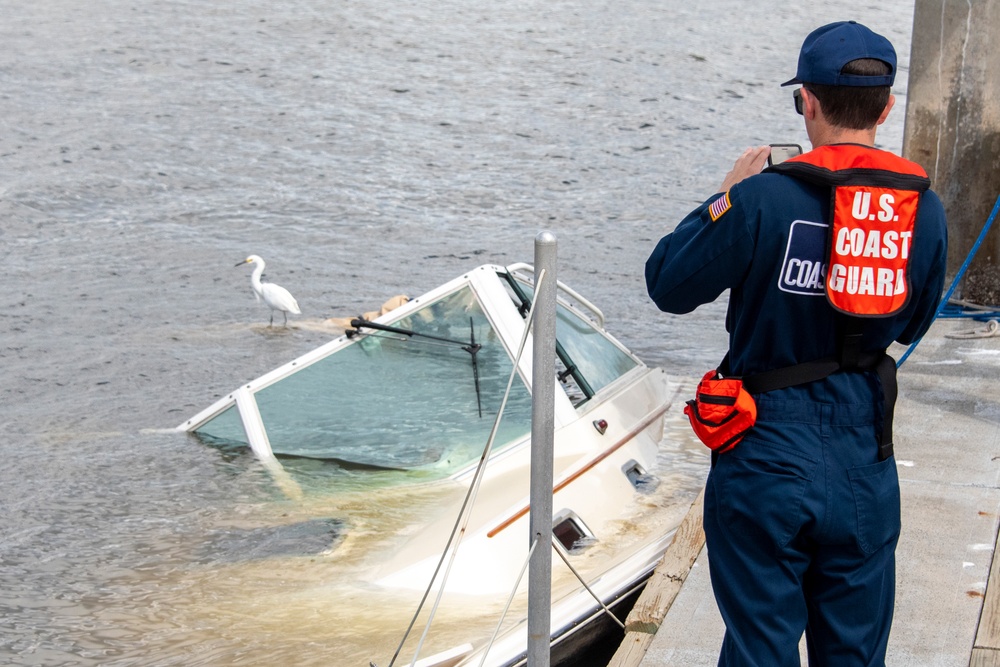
[{"left": 196, "top": 285, "right": 531, "bottom": 476}]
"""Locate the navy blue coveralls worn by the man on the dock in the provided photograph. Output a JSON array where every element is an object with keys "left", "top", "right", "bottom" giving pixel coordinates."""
[{"left": 646, "top": 147, "right": 947, "bottom": 667}]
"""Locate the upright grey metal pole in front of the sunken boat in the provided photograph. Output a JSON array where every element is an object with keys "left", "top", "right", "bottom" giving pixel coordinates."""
[{"left": 527, "top": 232, "right": 556, "bottom": 667}]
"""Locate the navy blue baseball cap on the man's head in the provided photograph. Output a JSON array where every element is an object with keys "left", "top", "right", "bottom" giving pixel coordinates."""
[{"left": 781, "top": 21, "right": 896, "bottom": 86}]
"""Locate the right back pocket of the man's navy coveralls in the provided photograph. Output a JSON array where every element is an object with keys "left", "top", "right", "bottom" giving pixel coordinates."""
[{"left": 847, "top": 457, "right": 900, "bottom": 554}]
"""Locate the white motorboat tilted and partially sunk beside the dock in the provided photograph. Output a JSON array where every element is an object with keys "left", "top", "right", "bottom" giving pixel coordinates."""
[{"left": 178, "top": 264, "right": 679, "bottom": 667}]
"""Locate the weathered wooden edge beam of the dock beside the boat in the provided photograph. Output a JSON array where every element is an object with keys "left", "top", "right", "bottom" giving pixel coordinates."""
[{"left": 608, "top": 489, "right": 705, "bottom": 667}]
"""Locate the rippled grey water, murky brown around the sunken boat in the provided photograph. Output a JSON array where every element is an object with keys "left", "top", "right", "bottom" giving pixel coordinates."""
[{"left": 0, "top": 0, "right": 912, "bottom": 665}]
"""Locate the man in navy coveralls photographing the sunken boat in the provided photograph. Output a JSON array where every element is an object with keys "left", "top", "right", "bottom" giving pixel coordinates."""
[{"left": 646, "top": 22, "right": 947, "bottom": 667}]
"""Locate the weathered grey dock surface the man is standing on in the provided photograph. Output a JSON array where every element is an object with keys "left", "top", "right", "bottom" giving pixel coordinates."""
[{"left": 610, "top": 319, "right": 1000, "bottom": 667}]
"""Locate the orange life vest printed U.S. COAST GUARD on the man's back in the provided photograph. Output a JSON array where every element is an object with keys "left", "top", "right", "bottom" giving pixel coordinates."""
[{"left": 770, "top": 144, "right": 930, "bottom": 317}]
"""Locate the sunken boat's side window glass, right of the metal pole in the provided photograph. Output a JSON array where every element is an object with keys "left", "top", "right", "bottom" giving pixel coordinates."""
[{"left": 504, "top": 281, "right": 637, "bottom": 405}]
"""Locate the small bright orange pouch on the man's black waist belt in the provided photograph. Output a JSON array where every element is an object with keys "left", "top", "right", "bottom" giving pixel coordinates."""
[{"left": 684, "top": 371, "right": 757, "bottom": 452}]
